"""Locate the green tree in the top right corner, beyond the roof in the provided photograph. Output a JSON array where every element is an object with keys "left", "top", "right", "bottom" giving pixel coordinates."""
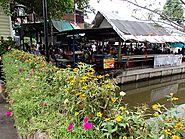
[{"left": 162, "top": 0, "right": 184, "bottom": 24}]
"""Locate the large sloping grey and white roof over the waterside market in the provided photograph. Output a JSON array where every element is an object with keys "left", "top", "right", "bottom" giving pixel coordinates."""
[{"left": 93, "top": 11, "right": 185, "bottom": 43}]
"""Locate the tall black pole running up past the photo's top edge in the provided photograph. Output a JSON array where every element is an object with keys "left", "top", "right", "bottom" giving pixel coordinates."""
[{"left": 42, "top": 0, "right": 49, "bottom": 62}]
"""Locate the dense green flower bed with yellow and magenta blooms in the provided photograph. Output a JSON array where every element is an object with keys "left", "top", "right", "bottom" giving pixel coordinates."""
[{"left": 3, "top": 50, "right": 184, "bottom": 139}]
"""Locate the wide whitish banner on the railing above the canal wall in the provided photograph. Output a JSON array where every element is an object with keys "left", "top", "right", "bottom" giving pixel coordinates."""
[{"left": 154, "top": 54, "right": 182, "bottom": 68}]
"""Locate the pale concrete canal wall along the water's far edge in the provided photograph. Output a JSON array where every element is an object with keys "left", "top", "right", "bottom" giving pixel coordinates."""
[{"left": 114, "top": 63, "right": 185, "bottom": 84}]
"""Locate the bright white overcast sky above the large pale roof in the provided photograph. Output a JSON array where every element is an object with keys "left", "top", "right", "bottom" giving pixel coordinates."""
[{"left": 85, "top": 0, "right": 166, "bottom": 23}]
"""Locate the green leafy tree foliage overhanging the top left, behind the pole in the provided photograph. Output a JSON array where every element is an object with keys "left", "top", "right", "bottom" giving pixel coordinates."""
[{"left": 0, "top": 0, "right": 90, "bottom": 18}]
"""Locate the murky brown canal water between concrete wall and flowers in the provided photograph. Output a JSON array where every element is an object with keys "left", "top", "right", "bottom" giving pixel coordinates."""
[{"left": 120, "top": 74, "right": 185, "bottom": 107}]
